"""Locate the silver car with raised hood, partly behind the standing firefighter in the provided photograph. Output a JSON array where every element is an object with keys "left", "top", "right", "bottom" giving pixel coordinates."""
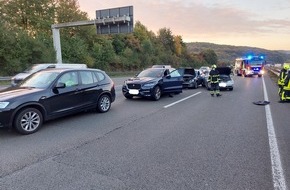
[{"left": 206, "top": 67, "right": 234, "bottom": 91}]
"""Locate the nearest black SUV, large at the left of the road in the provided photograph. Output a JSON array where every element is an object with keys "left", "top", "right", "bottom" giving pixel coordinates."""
[{"left": 0, "top": 68, "right": 116, "bottom": 134}]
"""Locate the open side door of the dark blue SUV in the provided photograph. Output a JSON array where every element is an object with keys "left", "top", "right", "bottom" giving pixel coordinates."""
[{"left": 163, "top": 69, "right": 183, "bottom": 92}]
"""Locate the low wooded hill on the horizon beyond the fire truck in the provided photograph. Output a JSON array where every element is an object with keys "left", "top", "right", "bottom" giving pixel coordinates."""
[{"left": 186, "top": 42, "right": 290, "bottom": 64}]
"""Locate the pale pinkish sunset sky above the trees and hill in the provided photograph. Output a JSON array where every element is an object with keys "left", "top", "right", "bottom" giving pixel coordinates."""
[{"left": 78, "top": 0, "right": 290, "bottom": 50}]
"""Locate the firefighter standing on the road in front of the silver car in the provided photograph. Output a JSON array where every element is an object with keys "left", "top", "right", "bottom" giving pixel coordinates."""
[{"left": 208, "top": 65, "right": 221, "bottom": 96}]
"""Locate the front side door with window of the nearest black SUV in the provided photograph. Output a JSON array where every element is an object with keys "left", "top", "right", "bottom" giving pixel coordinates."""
[{"left": 48, "top": 71, "right": 84, "bottom": 117}]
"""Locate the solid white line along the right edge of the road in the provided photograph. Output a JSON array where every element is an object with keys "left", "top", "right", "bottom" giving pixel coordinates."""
[{"left": 262, "top": 77, "right": 287, "bottom": 190}]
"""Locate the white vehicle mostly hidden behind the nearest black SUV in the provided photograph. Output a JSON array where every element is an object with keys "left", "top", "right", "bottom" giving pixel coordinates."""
[{"left": 11, "top": 63, "right": 87, "bottom": 86}]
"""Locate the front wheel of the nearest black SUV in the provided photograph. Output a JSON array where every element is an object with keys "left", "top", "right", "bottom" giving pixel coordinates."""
[{"left": 14, "top": 108, "right": 43, "bottom": 135}]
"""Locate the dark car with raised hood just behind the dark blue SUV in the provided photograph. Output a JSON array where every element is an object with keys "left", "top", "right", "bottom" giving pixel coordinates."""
[{"left": 177, "top": 67, "right": 199, "bottom": 88}]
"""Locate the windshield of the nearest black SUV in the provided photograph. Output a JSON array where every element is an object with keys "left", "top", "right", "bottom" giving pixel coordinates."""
[{"left": 20, "top": 72, "right": 59, "bottom": 88}]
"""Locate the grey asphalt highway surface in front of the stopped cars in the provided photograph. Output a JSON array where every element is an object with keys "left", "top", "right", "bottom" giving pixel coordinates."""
[{"left": 0, "top": 72, "right": 290, "bottom": 190}]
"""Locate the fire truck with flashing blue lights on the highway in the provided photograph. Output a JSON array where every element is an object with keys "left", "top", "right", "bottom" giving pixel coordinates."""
[{"left": 235, "top": 56, "right": 266, "bottom": 77}]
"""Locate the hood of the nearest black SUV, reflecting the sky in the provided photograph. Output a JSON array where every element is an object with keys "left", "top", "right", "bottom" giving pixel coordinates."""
[{"left": 0, "top": 87, "right": 43, "bottom": 101}]
